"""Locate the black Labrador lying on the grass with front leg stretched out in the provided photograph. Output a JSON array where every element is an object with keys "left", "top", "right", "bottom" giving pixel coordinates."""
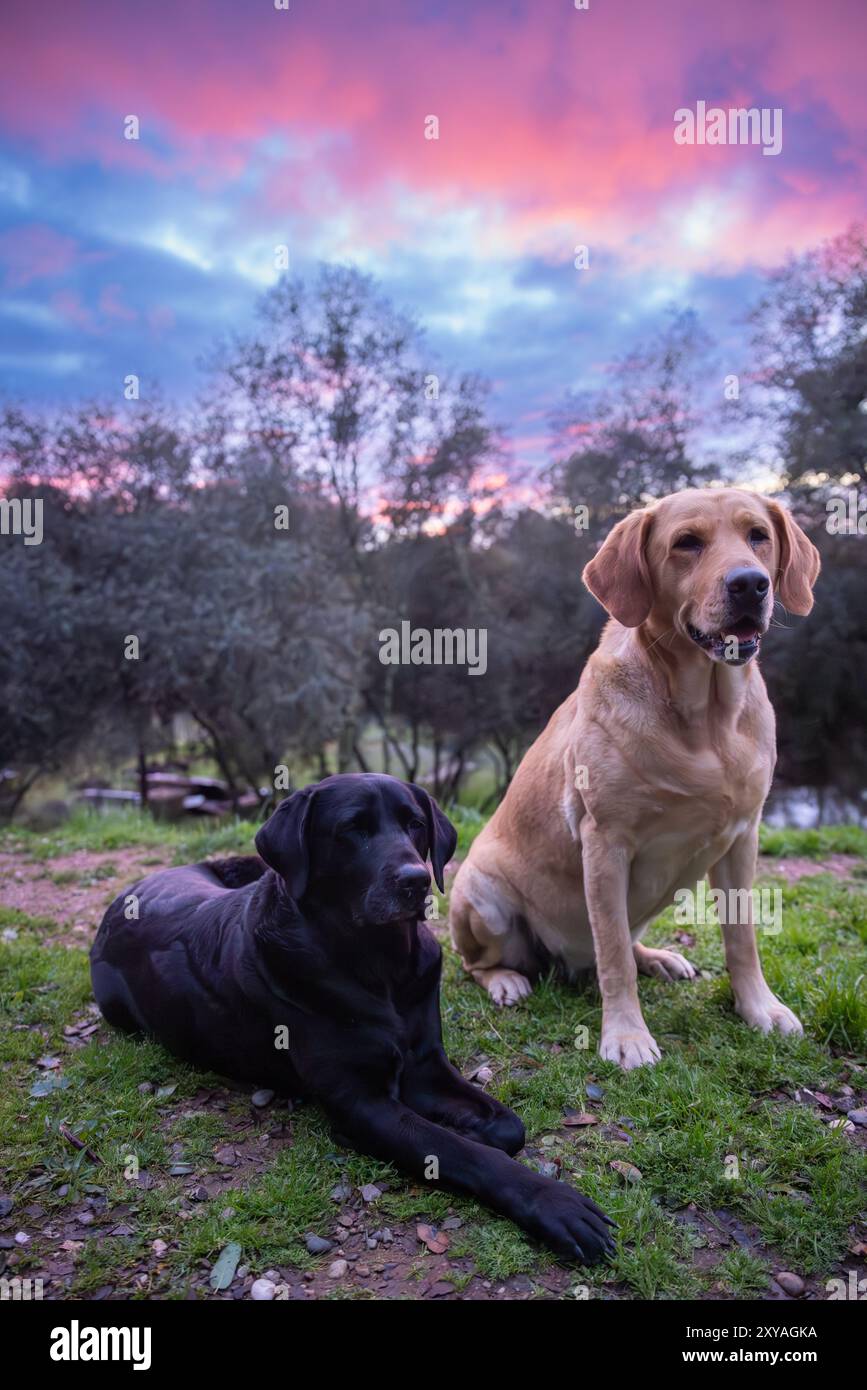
[{"left": 90, "top": 774, "right": 611, "bottom": 1264}]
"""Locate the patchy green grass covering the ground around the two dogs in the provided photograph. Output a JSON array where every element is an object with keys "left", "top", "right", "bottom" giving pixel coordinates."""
[{"left": 0, "top": 812, "right": 867, "bottom": 1298}]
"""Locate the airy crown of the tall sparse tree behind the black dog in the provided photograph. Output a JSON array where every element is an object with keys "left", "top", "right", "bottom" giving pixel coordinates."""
[{"left": 214, "top": 265, "right": 495, "bottom": 552}]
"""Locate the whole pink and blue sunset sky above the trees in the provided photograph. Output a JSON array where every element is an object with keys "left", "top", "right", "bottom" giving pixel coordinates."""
[{"left": 0, "top": 0, "right": 867, "bottom": 460}]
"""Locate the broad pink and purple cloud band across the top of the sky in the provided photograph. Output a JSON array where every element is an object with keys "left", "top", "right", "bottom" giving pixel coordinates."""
[{"left": 0, "top": 0, "right": 867, "bottom": 267}]
